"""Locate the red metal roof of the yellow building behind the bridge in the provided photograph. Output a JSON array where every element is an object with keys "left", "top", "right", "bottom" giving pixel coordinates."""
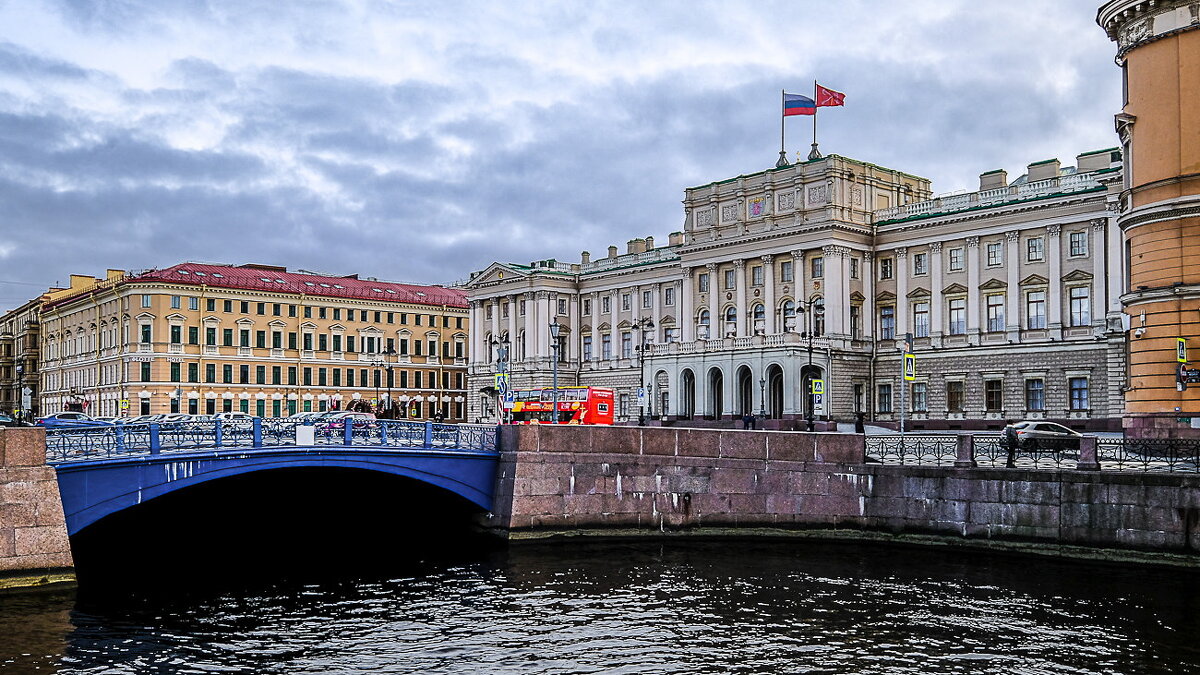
[{"left": 125, "top": 263, "right": 467, "bottom": 307}]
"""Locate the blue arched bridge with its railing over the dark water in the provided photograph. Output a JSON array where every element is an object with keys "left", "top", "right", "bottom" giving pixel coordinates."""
[{"left": 46, "top": 419, "right": 499, "bottom": 534}]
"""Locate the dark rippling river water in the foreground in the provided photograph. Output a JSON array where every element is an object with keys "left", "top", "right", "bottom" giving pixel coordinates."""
[{"left": 7, "top": 539, "right": 1200, "bottom": 674}]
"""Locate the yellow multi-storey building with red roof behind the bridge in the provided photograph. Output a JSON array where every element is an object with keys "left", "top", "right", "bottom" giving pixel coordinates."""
[{"left": 41, "top": 263, "right": 469, "bottom": 422}]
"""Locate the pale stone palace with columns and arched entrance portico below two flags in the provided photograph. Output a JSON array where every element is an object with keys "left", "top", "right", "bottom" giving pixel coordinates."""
[{"left": 467, "top": 149, "right": 1126, "bottom": 429}]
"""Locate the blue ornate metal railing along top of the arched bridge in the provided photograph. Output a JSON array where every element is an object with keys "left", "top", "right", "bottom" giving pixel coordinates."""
[{"left": 46, "top": 418, "right": 497, "bottom": 464}]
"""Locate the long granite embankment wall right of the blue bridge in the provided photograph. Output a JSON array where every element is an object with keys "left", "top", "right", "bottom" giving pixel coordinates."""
[{"left": 492, "top": 426, "right": 1200, "bottom": 561}]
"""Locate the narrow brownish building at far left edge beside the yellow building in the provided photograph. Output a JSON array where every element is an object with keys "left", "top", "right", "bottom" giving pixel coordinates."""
[{"left": 0, "top": 297, "right": 43, "bottom": 420}]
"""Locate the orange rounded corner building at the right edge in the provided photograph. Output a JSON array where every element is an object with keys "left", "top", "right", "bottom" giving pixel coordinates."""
[{"left": 1097, "top": 0, "right": 1200, "bottom": 437}]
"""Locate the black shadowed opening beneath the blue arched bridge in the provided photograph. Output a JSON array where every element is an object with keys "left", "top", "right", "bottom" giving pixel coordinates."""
[{"left": 71, "top": 467, "right": 497, "bottom": 592}]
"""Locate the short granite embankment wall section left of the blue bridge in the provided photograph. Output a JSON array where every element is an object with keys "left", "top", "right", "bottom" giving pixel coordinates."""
[{"left": 0, "top": 428, "right": 74, "bottom": 589}]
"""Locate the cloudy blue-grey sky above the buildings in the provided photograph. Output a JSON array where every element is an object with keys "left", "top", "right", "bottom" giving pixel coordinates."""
[{"left": 0, "top": 0, "right": 1121, "bottom": 311}]
